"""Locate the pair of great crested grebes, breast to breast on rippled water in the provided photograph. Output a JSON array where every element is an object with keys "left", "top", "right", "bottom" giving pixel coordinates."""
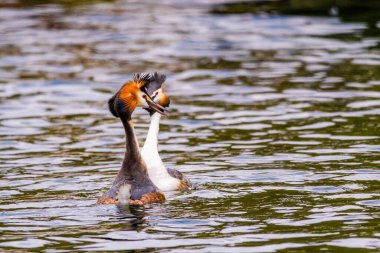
[{"left": 97, "top": 72, "right": 190, "bottom": 205}]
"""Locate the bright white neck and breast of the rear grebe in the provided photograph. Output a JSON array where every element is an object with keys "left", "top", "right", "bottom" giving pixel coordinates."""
[{"left": 141, "top": 112, "right": 178, "bottom": 191}]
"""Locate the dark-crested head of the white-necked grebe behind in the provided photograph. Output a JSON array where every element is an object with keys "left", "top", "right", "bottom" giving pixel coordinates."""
[{"left": 145, "top": 72, "right": 170, "bottom": 115}]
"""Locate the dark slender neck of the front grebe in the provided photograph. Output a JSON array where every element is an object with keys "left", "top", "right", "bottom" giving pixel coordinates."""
[{"left": 120, "top": 115, "right": 147, "bottom": 179}]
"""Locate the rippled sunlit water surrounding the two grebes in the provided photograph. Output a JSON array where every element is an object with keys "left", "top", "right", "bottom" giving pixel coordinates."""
[{"left": 0, "top": 0, "right": 380, "bottom": 252}]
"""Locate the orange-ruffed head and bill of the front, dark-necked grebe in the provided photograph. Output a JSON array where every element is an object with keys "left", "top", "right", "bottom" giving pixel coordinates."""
[{"left": 108, "top": 73, "right": 167, "bottom": 118}]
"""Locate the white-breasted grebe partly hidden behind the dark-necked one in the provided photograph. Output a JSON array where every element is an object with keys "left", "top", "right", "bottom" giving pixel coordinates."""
[{"left": 141, "top": 72, "right": 190, "bottom": 191}]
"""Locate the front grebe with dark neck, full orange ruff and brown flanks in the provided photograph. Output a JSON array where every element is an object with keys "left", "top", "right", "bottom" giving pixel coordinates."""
[{"left": 97, "top": 74, "right": 166, "bottom": 205}]
